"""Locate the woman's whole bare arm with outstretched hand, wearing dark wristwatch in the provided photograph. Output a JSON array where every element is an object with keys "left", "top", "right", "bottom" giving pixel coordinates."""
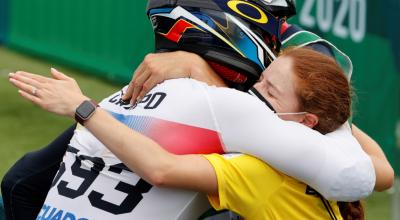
[{"left": 10, "top": 69, "right": 217, "bottom": 194}]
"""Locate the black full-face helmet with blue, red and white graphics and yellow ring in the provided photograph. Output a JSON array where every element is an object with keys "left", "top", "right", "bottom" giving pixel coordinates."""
[{"left": 147, "top": 0, "right": 296, "bottom": 91}]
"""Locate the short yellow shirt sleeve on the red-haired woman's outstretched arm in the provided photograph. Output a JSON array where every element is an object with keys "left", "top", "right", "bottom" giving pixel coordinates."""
[{"left": 205, "top": 154, "right": 284, "bottom": 217}]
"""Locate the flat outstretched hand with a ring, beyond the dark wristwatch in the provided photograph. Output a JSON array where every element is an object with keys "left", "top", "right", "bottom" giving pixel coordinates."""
[{"left": 9, "top": 68, "right": 88, "bottom": 118}]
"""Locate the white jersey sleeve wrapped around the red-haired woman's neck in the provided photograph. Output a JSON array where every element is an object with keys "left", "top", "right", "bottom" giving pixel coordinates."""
[{"left": 205, "top": 87, "right": 375, "bottom": 201}]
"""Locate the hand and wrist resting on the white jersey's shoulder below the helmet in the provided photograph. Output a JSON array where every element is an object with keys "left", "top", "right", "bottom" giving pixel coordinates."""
[{"left": 122, "top": 51, "right": 225, "bottom": 103}]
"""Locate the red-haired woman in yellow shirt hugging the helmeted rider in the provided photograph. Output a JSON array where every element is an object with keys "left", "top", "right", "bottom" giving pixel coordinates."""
[{"left": 11, "top": 49, "right": 390, "bottom": 219}]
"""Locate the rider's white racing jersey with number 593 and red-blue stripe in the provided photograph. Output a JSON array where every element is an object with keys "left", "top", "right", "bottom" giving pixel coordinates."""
[{"left": 37, "top": 79, "right": 375, "bottom": 220}]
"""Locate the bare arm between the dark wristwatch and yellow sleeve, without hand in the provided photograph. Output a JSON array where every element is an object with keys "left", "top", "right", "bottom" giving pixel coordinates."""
[{"left": 84, "top": 106, "right": 217, "bottom": 194}]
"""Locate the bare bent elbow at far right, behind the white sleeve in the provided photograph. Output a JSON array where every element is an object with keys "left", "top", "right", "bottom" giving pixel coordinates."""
[{"left": 352, "top": 124, "right": 394, "bottom": 191}]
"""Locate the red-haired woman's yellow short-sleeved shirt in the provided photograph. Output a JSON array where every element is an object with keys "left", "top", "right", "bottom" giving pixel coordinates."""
[{"left": 205, "top": 154, "right": 342, "bottom": 220}]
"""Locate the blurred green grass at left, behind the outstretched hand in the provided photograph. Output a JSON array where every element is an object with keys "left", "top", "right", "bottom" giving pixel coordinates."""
[{"left": 0, "top": 47, "right": 121, "bottom": 177}]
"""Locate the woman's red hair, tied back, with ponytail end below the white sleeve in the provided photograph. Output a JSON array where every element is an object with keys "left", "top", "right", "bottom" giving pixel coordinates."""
[{"left": 282, "top": 48, "right": 364, "bottom": 220}]
